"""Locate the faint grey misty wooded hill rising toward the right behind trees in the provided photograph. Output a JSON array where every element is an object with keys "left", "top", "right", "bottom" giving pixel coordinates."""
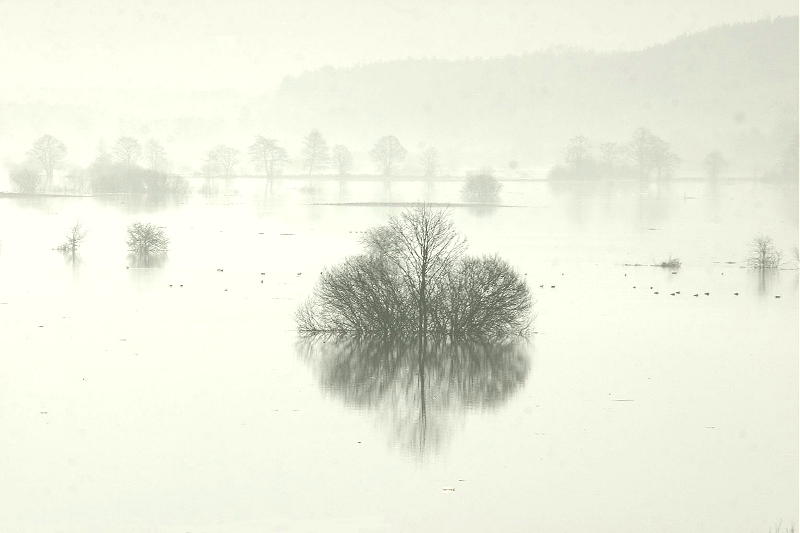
[{"left": 269, "top": 17, "right": 798, "bottom": 174}]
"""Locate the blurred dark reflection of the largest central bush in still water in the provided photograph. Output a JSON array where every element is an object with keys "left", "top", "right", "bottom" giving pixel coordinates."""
[{"left": 297, "top": 337, "right": 530, "bottom": 456}]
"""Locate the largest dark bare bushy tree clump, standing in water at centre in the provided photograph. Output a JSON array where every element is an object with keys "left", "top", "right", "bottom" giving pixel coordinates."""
[{"left": 296, "top": 206, "right": 531, "bottom": 338}]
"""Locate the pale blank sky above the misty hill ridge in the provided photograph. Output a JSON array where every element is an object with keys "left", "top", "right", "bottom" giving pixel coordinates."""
[{"left": 0, "top": 0, "right": 798, "bottom": 90}]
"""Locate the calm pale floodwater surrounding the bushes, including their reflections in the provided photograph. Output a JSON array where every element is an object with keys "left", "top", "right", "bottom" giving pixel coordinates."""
[{"left": 0, "top": 179, "right": 798, "bottom": 533}]
